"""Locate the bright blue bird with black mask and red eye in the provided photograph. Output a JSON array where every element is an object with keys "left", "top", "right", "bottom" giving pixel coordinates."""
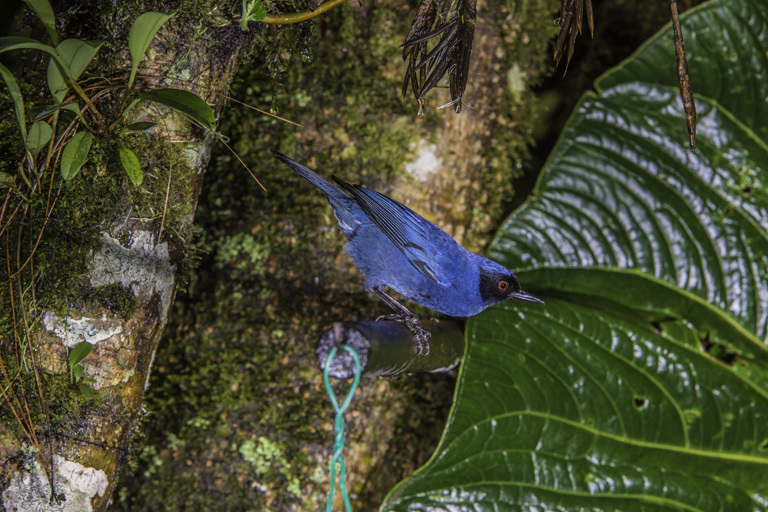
[{"left": 272, "top": 150, "right": 543, "bottom": 353}]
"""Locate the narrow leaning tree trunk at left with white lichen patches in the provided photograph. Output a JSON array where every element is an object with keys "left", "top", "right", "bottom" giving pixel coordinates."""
[{"left": 0, "top": 2, "right": 245, "bottom": 512}]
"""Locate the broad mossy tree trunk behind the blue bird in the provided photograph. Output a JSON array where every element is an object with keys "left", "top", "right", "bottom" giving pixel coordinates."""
[{"left": 109, "top": 0, "right": 556, "bottom": 511}]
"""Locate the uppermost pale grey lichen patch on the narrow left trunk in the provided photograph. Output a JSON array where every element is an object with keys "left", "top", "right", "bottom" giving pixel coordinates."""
[{"left": 90, "top": 231, "right": 175, "bottom": 323}]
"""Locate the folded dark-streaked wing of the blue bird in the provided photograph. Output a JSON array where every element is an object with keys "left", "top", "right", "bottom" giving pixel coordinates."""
[{"left": 331, "top": 176, "right": 450, "bottom": 285}]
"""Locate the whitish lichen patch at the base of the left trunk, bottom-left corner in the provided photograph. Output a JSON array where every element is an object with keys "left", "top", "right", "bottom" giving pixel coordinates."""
[{"left": 2, "top": 455, "right": 109, "bottom": 512}]
